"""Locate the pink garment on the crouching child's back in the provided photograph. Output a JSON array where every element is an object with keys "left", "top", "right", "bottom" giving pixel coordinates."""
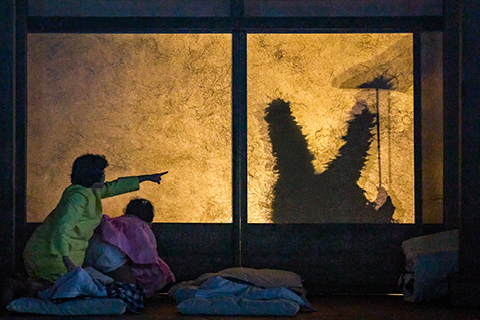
[{"left": 87, "top": 215, "right": 175, "bottom": 298}]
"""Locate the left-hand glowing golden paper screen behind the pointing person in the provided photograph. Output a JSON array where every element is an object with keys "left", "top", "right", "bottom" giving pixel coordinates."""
[{"left": 27, "top": 34, "right": 232, "bottom": 222}]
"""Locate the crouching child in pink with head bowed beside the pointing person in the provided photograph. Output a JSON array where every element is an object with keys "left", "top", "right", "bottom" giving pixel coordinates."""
[{"left": 83, "top": 199, "right": 175, "bottom": 298}]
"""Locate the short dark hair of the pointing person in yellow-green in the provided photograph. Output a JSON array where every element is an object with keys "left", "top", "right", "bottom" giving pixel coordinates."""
[{"left": 70, "top": 153, "right": 108, "bottom": 188}]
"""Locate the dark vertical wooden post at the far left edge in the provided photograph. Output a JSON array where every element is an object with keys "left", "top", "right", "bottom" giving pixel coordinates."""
[{"left": 0, "top": 0, "right": 15, "bottom": 282}]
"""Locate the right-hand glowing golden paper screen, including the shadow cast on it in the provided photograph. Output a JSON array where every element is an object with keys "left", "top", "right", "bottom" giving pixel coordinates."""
[{"left": 247, "top": 34, "right": 415, "bottom": 223}]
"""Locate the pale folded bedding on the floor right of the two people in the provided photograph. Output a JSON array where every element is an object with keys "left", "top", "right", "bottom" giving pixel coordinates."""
[{"left": 168, "top": 268, "right": 315, "bottom": 316}]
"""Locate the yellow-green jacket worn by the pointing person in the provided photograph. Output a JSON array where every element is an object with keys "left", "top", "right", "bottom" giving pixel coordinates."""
[{"left": 23, "top": 177, "right": 139, "bottom": 282}]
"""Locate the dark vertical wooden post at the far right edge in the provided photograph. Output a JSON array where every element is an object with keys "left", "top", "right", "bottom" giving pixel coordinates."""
[{"left": 447, "top": 0, "right": 480, "bottom": 306}]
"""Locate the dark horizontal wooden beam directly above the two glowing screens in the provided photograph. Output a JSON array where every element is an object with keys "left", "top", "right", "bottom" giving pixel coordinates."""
[{"left": 28, "top": 16, "right": 444, "bottom": 33}]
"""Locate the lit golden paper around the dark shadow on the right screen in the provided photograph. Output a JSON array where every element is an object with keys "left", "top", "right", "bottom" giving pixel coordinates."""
[{"left": 247, "top": 34, "right": 415, "bottom": 223}]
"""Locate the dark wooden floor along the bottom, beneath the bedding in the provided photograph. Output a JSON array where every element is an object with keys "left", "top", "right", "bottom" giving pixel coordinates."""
[{"left": 1, "top": 295, "right": 480, "bottom": 320}]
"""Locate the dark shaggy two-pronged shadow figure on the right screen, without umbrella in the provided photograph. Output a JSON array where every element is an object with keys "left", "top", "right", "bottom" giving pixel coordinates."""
[{"left": 265, "top": 99, "right": 395, "bottom": 223}]
